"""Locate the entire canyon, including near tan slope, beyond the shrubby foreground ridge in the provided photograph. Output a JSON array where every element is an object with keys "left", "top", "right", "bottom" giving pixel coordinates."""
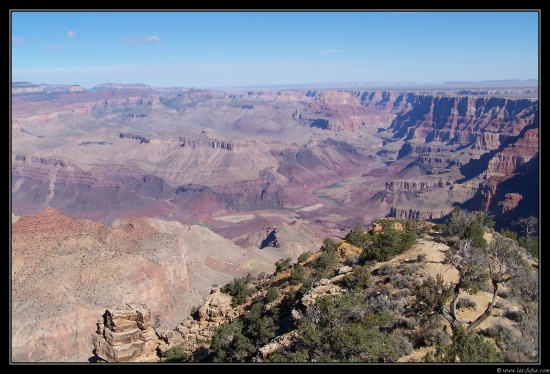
[{"left": 10, "top": 82, "right": 540, "bottom": 361}]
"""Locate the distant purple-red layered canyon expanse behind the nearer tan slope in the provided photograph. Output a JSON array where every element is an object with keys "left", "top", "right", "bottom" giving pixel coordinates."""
[{"left": 12, "top": 84, "right": 538, "bottom": 234}]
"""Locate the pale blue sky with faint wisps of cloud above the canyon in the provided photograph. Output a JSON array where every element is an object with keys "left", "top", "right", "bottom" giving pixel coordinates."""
[{"left": 11, "top": 10, "right": 540, "bottom": 88}]
